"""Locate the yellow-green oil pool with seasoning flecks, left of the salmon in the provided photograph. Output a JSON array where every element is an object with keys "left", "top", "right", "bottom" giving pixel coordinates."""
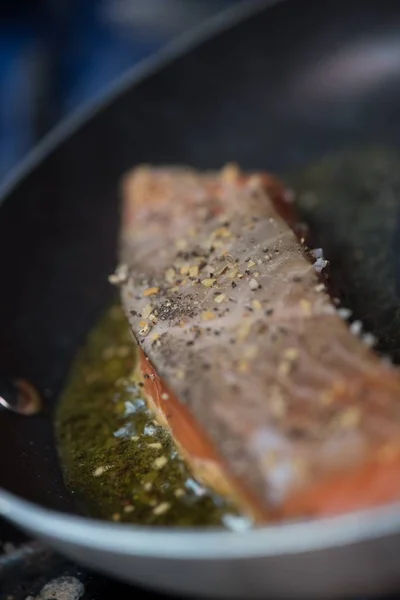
[{"left": 56, "top": 306, "right": 242, "bottom": 527}]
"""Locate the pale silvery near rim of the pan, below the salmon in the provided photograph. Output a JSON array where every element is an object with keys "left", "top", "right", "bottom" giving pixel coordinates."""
[{"left": 0, "top": 489, "right": 400, "bottom": 560}]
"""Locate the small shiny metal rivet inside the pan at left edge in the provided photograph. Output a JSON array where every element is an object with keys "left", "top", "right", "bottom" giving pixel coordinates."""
[{"left": 0, "top": 376, "right": 43, "bottom": 416}]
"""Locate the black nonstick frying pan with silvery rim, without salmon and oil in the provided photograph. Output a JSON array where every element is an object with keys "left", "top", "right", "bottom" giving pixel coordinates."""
[{"left": 0, "top": 0, "right": 400, "bottom": 598}]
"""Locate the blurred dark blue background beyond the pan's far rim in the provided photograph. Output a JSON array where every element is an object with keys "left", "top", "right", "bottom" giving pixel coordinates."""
[{"left": 0, "top": 0, "right": 242, "bottom": 181}]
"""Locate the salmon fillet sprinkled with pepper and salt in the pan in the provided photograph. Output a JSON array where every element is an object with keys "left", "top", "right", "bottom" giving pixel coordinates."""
[{"left": 114, "top": 167, "right": 400, "bottom": 521}]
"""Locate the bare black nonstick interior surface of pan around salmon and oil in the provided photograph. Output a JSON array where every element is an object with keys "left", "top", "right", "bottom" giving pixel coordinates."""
[{"left": 0, "top": 0, "right": 400, "bottom": 528}]
